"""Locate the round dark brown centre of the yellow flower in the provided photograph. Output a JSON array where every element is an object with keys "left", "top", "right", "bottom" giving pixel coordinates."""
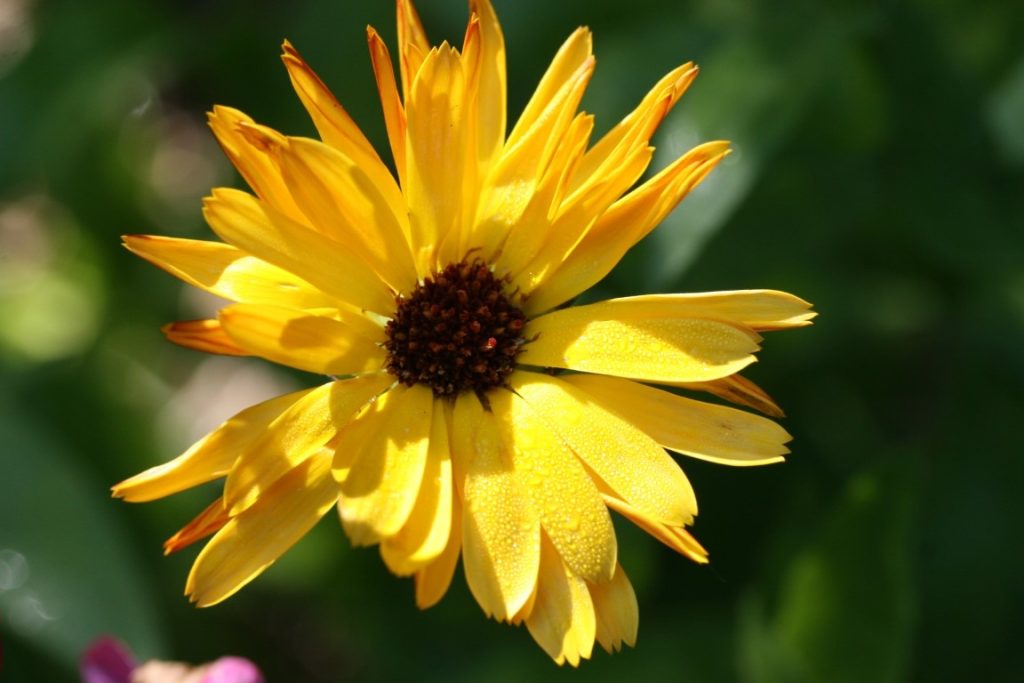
[{"left": 384, "top": 260, "right": 526, "bottom": 397}]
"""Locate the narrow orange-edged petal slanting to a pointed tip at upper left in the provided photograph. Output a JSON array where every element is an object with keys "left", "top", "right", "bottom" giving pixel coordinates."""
[{"left": 282, "top": 41, "right": 401, "bottom": 216}]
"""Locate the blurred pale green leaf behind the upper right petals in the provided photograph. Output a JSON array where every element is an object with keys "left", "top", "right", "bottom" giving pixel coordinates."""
[{"left": 634, "top": 11, "right": 850, "bottom": 289}]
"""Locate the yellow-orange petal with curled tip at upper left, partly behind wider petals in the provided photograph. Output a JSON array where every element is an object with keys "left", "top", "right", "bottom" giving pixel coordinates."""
[{"left": 208, "top": 104, "right": 305, "bottom": 222}]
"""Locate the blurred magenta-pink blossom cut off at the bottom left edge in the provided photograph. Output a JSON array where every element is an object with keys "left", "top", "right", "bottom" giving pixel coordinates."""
[{"left": 80, "top": 636, "right": 263, "bottom": 683}]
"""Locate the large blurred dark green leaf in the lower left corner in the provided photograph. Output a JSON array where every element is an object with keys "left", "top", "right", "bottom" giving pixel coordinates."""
[{"left": 0, "top": 401, "right": 167, "bottom": 666}]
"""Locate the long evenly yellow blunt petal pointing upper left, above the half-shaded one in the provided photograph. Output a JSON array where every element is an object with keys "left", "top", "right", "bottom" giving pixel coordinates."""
[{"left": 203, "top": 188, "right": 394, "bottom": 313}]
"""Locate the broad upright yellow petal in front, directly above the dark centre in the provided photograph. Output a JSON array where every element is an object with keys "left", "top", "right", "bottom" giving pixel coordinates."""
[{"left": 404, "top": 43, "right": 467, "bottom": 278}]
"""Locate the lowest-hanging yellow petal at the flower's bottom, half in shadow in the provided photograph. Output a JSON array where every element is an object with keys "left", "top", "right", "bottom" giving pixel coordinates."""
[{"left": 526, "top": 535, "right": 597, "bottom": 667}]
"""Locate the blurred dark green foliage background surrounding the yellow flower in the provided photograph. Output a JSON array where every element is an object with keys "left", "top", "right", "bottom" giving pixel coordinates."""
[{"left": 0, "top": 0, "right": 1024, "bottom": 683}]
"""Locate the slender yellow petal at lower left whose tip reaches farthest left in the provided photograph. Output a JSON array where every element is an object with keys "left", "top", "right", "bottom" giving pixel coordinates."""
[{"left": 113, "top": 389, "right": 312, "bottom": 503}]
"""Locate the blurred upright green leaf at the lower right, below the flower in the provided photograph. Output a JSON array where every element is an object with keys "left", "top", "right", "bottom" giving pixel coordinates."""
[{"left": 740, "top": 456, "right": 918, "bottom": 683}]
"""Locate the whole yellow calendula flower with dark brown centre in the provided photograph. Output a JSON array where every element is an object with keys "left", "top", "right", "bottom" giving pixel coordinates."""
[{"left": 114, "top": 0, "right": 813, "bottom": 666}]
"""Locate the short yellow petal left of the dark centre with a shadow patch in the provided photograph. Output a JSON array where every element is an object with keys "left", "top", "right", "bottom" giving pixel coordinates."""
[{"left": 219, "top": 303, "right": 386, "bottom": 375}]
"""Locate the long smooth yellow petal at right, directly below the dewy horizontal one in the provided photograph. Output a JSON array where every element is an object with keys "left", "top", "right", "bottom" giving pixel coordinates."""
[{"left": 565, "top": 375, "right": 792, "bottom": 465}]
